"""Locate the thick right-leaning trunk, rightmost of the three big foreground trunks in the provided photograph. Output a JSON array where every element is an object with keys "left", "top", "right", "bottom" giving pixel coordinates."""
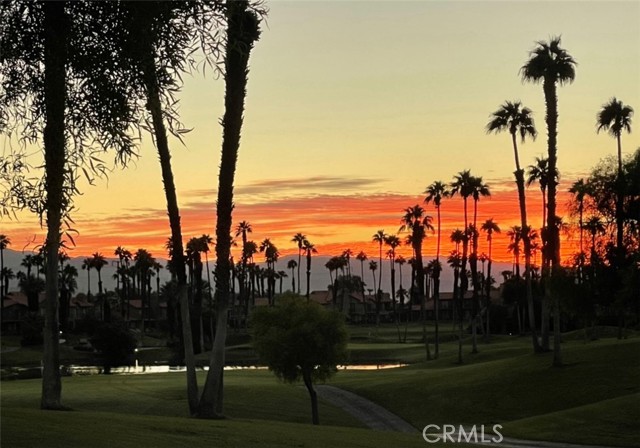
[{"left": 198, "top": 1, "right": 259, "bottom": 418}]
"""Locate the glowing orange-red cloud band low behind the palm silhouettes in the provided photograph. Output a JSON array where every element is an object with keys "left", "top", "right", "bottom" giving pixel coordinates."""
[{"left": 3, "top": 178, "right": 577, "bottom": 262}]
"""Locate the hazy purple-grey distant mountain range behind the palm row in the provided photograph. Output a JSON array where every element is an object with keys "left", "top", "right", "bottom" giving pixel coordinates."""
[{"left": 4, "top": 249, "right": 511, "bottom": 294}]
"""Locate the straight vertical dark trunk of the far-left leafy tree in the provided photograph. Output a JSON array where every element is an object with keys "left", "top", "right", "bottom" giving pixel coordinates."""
[{"left": 40, "top": 2, "right": 67, "bottom": 409}]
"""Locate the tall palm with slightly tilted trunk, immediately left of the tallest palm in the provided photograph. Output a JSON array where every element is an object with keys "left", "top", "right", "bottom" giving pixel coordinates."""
[{"left": 484, "top": 101, "right": 541, "bottom": 353}]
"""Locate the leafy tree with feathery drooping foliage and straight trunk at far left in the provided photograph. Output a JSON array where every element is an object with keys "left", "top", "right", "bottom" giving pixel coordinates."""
[{"left": 0, "top": 1, "right": 140, "bottom": 409}]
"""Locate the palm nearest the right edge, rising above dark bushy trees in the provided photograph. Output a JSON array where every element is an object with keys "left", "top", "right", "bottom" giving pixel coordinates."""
[{"left": 596, "top": 97, "right": 633, "bottom": 264}]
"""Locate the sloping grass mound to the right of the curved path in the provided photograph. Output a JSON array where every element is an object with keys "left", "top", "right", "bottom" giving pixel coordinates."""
[{"left": 332, "top": 338, "right": 640, "bottom": 446}]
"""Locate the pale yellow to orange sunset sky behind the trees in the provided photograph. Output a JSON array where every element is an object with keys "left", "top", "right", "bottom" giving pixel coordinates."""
[{"left": 0, "top": 1, "right": 640, "bottom": 268}]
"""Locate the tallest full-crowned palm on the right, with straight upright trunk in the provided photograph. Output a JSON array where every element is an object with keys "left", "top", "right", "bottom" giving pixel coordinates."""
[{"left": 520, "top": 37, "right": 576, "bottom": 367}]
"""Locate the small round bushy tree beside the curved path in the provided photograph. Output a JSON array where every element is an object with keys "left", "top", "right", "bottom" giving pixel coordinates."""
[{"left": 251, "top": 297, "right": 348, "bottom": 425}]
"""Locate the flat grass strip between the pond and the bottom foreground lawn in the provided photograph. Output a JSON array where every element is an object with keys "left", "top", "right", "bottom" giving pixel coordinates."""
[{"left": 1, "top": 370, "right": 362, "bottom": 426}]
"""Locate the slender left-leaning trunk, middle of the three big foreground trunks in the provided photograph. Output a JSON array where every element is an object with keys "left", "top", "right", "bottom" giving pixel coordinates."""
[{"left": 142, "top": 48, "right": 198, "bottom": 415}]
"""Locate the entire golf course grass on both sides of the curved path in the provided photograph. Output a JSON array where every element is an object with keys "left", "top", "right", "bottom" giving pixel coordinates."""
[{"left": 1, "top": 325, "right": 640, "bottom": 447}]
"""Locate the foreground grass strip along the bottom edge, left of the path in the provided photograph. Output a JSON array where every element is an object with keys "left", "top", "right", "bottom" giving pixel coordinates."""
[{"left": 2, "top": 409, "right": 425, "bottom": 448}]
